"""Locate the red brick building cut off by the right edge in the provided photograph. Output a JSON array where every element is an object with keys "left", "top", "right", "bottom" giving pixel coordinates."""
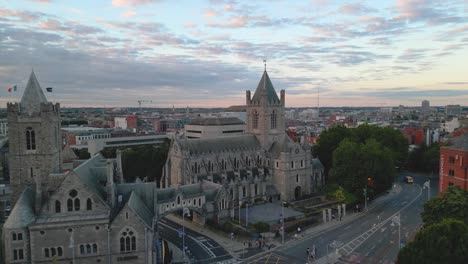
[{"left": 439, "top": 134, "right": 468, "bottom": 194}]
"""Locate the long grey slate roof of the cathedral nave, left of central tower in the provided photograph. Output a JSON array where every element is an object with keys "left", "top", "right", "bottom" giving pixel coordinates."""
[{"left": 178, "top": 135, "right": 261, "bottom": 153}]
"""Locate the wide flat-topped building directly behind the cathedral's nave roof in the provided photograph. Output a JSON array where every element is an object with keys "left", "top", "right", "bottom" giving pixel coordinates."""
[{"left": 184, "top": 117, "right": 245, "bottom": 138}]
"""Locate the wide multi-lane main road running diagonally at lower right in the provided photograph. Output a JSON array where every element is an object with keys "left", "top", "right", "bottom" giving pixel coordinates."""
[{"left": 249, "top": 173, "right": 438, "bottom": 264}]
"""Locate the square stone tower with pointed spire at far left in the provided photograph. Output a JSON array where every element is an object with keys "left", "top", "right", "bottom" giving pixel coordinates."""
[{"left": 7, "top": 72, "right": 62, "bottom": 207}]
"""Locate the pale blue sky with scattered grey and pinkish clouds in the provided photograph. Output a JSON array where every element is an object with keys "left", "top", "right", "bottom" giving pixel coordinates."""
[{"left": 0, "top": 0, "right": 468, "bottom": 107}]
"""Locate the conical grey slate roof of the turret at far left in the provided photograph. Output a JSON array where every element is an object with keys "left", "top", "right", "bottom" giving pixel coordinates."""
[{"left": 3, "top": 187, "right": 36, "bottom": 229}]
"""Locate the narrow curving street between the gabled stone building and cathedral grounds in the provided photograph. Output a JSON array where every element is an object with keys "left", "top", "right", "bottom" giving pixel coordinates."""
[{"left": 159, "top": 218, "right": 232, "bottom": 264}]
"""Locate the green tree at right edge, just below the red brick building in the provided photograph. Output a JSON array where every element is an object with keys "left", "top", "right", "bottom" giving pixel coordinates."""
[{"left": 421, "top": 186, "right": 468, "bottom": 226}]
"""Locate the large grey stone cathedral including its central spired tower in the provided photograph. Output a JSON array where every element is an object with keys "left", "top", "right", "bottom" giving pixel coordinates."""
[{"left": 161, "top": 71, "right": 324, "bottom": 203}]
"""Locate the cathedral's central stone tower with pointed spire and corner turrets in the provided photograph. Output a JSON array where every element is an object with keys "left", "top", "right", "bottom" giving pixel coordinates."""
[{"left": 246, "top": 69, "right": 285, "bottom": 150}]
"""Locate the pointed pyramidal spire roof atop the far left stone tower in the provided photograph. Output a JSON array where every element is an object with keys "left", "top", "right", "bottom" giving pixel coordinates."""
[{"left": 20, "top": 71, "right": 47, "bottom": 113}]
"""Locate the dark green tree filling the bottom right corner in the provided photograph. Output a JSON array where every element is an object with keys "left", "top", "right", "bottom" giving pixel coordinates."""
[{"left": 397, "top": 219, "right": 468, "bottom": 264}]
